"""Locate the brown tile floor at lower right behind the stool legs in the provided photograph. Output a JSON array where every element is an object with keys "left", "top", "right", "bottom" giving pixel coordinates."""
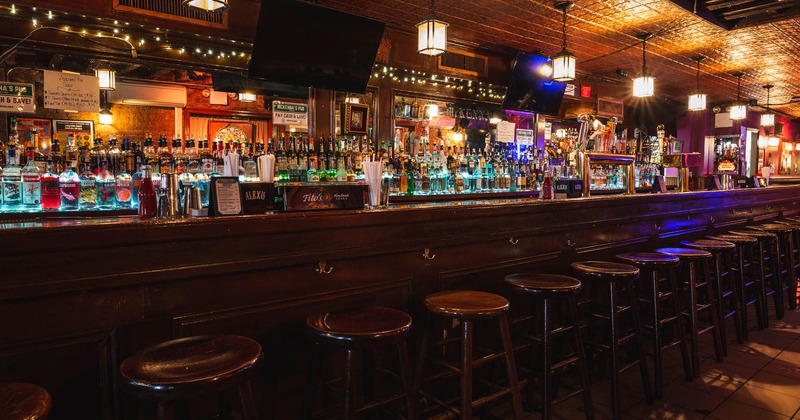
[{"left": 544, "top": 309, "right": 800, "bottom": 420}]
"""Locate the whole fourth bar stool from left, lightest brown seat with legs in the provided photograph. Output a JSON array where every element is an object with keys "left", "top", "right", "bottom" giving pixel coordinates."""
[{"left": 415, "top": 290, "right": 523, "bottom": 420}]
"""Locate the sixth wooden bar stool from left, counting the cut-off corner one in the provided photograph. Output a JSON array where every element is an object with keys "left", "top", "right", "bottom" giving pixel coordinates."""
[{"left": 571, "top": 261, "right": 653, "bottom": 419}]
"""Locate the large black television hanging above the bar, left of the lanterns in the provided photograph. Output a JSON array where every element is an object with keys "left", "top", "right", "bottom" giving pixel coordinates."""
[{"left": 248, "top": 0, "right": 386, "bottom": 93}]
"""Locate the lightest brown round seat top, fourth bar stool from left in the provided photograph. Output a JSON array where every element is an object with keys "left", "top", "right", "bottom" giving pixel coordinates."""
[{"left": 425, "top": 290, "right": 508, "bottom": 318}]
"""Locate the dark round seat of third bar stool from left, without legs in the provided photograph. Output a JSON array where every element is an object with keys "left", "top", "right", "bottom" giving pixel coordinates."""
[{"left": 306, "top": 307, "right": 411, "bottom": 346}]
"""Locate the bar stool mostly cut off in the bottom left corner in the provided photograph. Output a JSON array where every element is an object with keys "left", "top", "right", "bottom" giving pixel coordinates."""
[{"left": 0, "top": 383, "right": 53, "bottom": 420}]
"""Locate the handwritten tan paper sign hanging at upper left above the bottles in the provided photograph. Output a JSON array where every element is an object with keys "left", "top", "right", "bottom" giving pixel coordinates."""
[{"left": 44, "top": 70, "right": 100, "bottom": 112}]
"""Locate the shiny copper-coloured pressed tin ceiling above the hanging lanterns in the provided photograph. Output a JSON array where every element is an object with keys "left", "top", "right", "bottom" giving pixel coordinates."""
[{"left": 316, "top": 0, "right": 800, "bottom": 117}]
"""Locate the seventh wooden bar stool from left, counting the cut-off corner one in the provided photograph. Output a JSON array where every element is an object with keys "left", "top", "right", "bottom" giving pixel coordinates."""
[{"left": 617, "top": 252, "right": 692, "bottom": 398}]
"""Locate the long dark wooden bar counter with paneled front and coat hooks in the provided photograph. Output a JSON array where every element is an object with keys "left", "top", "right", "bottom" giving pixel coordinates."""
[{"left": 0, "top": 186, "right": 800, "bottom": 419}]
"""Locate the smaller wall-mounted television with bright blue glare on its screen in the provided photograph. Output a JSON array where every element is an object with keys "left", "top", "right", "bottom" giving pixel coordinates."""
[{"left": 503, "top": 52, "right": 567, "bottom": 116}]
